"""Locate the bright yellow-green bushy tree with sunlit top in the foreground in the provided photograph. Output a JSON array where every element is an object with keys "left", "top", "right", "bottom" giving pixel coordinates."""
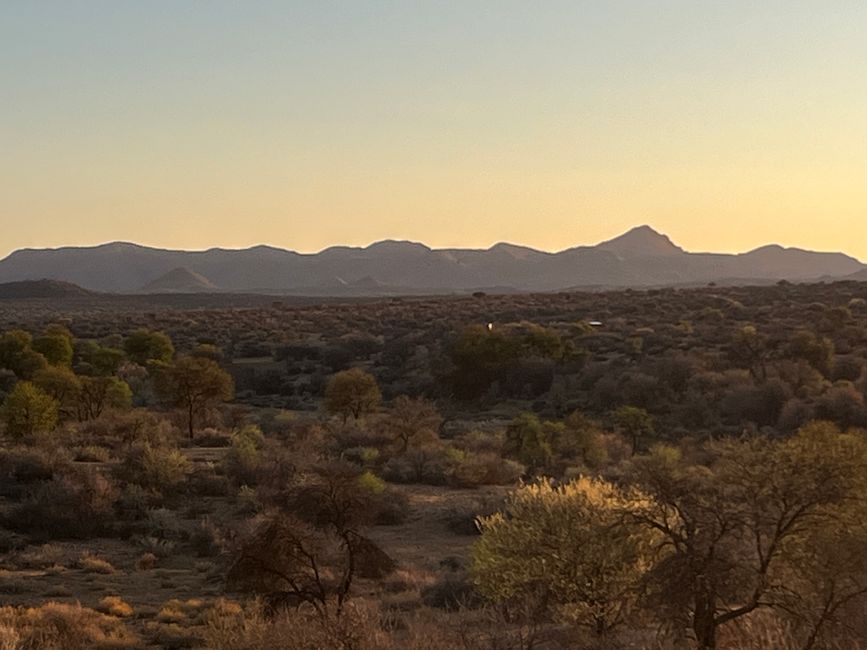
[{"left": 472, "top": 478, "right": 654, "bottom": 632}]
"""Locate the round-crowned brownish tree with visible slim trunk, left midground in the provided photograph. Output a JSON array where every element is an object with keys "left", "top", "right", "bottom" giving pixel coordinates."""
[{"left": 155, "top": 356, "right": 234, "bottom": 440}]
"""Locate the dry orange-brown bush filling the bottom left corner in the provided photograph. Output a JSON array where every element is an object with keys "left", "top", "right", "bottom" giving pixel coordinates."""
[{"left": 0, "top": 602, "right": 141, "bottom": 650}]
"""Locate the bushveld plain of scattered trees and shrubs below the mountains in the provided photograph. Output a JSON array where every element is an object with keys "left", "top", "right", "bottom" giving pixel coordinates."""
[{"left": 0, "top": 283, "right": 867, "bottom": 650}]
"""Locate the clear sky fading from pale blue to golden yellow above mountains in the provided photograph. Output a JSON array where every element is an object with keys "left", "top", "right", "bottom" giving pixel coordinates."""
[{"left": 0, "top": 0, "right": 867, "bottom": 260}]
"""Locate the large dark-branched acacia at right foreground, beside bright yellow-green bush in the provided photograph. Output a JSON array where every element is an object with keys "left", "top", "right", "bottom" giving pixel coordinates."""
[{"left": 629, "top": 424, "right": 867, "bottom": 649}]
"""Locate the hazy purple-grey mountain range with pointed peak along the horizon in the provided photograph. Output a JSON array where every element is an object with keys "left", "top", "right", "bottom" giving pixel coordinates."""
[{"left": 0, "top": 226, "right": 867, "bottom": 296}]
